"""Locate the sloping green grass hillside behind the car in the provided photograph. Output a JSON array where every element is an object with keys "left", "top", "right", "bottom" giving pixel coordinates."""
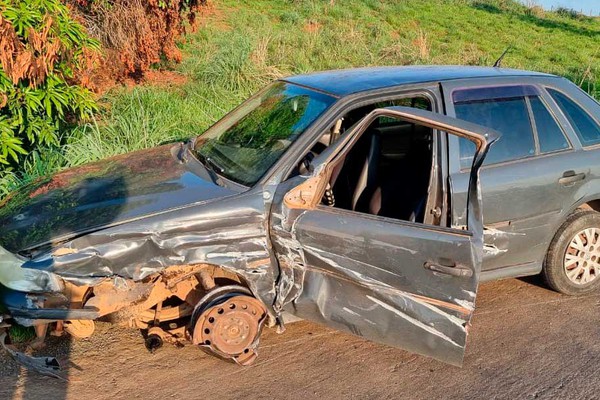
[{"left": 0, "top": 0, "right": 600, "bottom": 197}]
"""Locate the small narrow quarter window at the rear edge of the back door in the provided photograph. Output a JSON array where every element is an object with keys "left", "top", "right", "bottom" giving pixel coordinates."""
[{"left": 529, "top": 96, "right": 570, "bottom": 153}]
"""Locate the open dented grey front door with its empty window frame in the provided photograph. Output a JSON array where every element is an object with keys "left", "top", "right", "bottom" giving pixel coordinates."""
[{"left": 271, "top": 107, "right": 496, "bottom": 365}]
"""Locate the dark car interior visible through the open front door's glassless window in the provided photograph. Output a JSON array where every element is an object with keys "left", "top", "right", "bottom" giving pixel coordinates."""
[{"left": 298, "top": 97, "right": 433, "bottom": 223}]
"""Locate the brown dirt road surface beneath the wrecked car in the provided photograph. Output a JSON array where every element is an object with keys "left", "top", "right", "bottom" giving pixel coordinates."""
[{"left": 0, "top": 279, "right": 600, "bottom": 400}]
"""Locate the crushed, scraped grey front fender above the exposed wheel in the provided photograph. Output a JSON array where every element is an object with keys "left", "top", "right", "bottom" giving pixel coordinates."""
[{"left": 16, "top": 188, "right": 277, "bottom": 314}]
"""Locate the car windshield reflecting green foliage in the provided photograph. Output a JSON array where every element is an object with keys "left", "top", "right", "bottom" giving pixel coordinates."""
[{"left": 194, "top": 82, "right": 336, "bottom": 186}]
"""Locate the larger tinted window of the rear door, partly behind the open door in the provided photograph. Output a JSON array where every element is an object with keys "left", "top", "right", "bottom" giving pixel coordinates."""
[{"left": 453, "top": 86, "right": 535, "bottom": 168}]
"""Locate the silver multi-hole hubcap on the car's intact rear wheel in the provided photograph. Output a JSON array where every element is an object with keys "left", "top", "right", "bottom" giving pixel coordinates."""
[{"left": 564, "top": 228, "right": 600, "bottom": 285}]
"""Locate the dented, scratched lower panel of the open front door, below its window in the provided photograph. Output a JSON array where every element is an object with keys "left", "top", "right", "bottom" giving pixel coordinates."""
[{"left": 290, "top": 209, "right": 478, "bottom": 364}]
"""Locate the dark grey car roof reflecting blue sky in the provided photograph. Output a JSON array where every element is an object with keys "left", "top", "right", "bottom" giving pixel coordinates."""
[{"left": 282, "top": 65, "right": 555, "bottom": 97}]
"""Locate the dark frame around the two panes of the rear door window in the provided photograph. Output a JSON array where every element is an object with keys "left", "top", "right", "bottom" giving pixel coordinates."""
[{"left": 449, "top": 82, "right": 576, "bottom": 173}]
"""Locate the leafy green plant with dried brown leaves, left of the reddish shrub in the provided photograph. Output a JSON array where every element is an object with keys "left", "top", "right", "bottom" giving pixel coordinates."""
[{"left": 0, "top": 0, "right": 99, "bottom": 166}]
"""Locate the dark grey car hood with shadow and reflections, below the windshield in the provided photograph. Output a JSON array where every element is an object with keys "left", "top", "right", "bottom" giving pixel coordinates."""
[{"left": 0, "top": 145, "right": 236, "bottom": 253}]
